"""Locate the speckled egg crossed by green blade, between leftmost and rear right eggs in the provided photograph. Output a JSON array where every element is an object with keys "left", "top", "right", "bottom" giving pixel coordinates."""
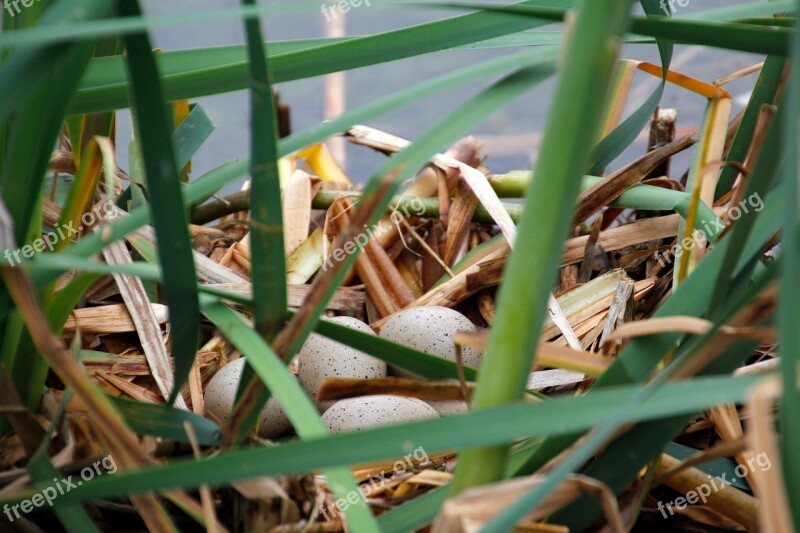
[{"left": 297, "top": 316, "right": 386, "bottom": 411}]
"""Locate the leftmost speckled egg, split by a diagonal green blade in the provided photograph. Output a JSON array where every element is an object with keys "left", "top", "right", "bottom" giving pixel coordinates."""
[{"left": 204, "top": 357, "right": 292, "bottom": 439}]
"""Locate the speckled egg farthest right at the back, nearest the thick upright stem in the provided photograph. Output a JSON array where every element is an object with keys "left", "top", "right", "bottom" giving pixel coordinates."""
[{"left": 380, "top": 305, "right": 483, "bottom": 377}]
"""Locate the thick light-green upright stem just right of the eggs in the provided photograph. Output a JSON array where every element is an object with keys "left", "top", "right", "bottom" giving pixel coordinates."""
[{"left": 453, "top": 0, "right": 630, "bottom": 492}]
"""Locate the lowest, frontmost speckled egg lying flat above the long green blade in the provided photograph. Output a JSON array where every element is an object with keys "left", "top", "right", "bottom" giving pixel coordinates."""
[{"left": 322, "top": 395, "right": 439, "bottom": 433}]
